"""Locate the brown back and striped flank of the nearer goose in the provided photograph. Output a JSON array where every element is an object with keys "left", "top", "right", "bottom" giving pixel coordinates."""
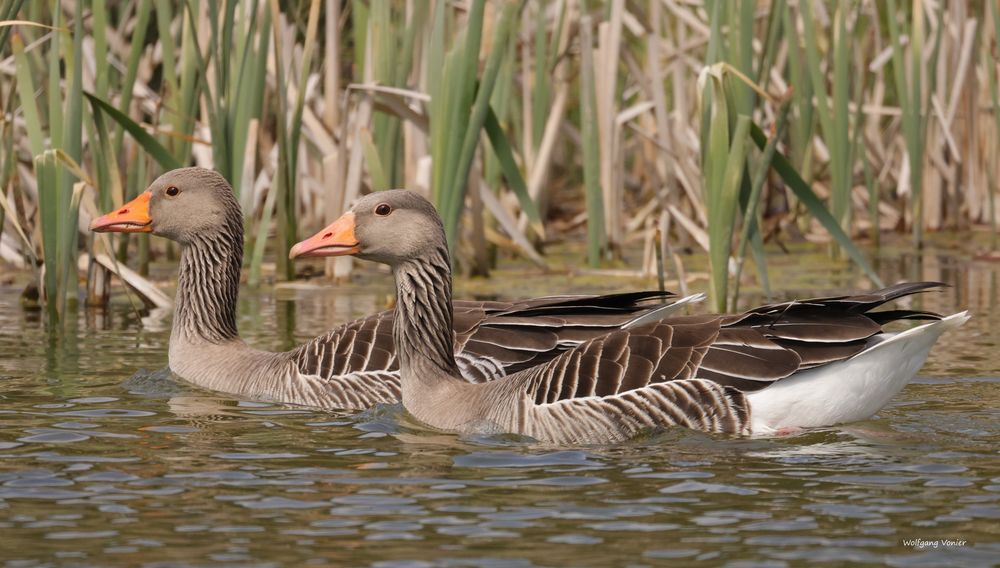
[{"left": 452, "top": 283, "right": 940, "bottom": 443}]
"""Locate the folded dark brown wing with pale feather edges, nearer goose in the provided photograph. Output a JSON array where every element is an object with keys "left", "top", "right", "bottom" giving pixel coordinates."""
[{"left": 526, "top": 282, "right": 941, "bottom": 404}]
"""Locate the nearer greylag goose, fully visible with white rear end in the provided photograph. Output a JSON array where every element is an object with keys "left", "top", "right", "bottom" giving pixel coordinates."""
[{"left": 292, "top": 190, "right": 968, "bottom": 444}]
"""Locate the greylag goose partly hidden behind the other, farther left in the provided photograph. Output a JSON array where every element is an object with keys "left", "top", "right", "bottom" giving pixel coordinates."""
[{"left": 90, "top": 168, "right": 679, "bottom": 410}]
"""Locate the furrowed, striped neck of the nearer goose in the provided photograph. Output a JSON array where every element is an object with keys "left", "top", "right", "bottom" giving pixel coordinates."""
[{"left": 392, "top": 244, "right": 461, "bottom": 377}]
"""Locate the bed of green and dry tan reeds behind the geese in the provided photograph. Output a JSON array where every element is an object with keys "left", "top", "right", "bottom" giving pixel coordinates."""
[{"left": 0, "top": 0, "right": 1000, "bottom": 323}]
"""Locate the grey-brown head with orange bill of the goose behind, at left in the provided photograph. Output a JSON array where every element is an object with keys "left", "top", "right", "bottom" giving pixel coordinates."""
[{"left": 90, "top": 168, "right": 243, "bottom": 244}]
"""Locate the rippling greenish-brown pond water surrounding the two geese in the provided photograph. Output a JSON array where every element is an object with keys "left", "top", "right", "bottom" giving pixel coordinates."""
[{"left": 0, "top": 246, "right": 1000, "bottom": 566}]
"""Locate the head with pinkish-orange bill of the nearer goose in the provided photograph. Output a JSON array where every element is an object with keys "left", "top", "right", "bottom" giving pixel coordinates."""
[{"left": 288, "top": 189, "right": 445, "bottom": 266}]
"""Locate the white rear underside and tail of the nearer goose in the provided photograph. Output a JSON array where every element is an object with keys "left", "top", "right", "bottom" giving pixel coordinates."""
[{"left": 747, "top": 312, "right": 969, "bottom": 434}]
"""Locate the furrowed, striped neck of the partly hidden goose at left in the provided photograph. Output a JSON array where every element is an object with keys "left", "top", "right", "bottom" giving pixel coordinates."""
[{"left": 173, "top": 221, "right": 243, "bottom": 343}]
